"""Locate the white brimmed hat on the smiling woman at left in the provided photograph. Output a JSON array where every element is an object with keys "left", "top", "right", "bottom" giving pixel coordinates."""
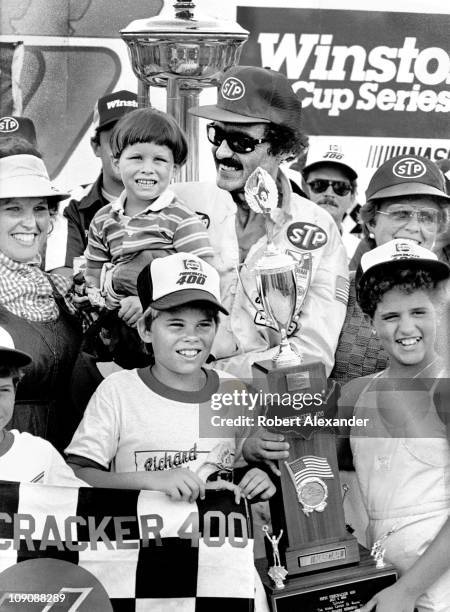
[{"left": 0, "top": 155, "right": 69, "bottom": 200}]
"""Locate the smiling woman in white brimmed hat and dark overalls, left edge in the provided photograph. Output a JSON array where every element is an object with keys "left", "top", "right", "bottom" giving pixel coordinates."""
[{"left": 0, "top": 139, "right": 81, "bottom": 449}]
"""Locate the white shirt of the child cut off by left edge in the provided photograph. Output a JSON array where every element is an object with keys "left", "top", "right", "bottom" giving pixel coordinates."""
[{"left": 0, "top": 429, "right": 85, "bottom": 487}]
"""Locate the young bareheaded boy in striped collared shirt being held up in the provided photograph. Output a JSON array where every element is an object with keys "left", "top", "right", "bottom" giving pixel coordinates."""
[{"left": 85, "top": 108, "right": 213, "bottom": 326}]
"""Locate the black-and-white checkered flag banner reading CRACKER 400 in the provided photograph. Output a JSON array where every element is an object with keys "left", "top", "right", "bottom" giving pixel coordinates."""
[{"left": 0, "top": 481, "right": 257, "bottom": 612}]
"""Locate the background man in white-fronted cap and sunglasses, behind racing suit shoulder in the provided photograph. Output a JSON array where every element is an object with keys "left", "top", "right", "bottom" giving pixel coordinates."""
[{"left": 302, "top": 144, "right": 359, "bottom": 258}]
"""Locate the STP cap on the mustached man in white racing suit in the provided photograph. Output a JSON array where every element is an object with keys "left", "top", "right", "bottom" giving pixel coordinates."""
[{"left": 189, "top": 66, "right": 302, "bottom": 129}]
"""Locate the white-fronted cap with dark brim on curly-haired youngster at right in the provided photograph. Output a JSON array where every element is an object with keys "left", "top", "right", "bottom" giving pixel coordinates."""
[{"left": 358, "top": 238, "right": 450, "bottom": 290}]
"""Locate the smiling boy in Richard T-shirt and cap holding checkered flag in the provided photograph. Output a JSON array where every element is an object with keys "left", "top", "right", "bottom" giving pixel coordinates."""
[{"left": 66, "top": 253, "right": 275, "bottom": 501}]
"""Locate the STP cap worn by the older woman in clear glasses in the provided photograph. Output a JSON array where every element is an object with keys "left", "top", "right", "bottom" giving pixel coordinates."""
[{"left": 366, "top": 155, "right": 450, "bottom": 201}]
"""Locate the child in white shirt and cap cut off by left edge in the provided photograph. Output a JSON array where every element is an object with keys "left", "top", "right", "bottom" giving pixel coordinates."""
[{"left": 0, "top": 327, "right": 86, "bottom": 487}]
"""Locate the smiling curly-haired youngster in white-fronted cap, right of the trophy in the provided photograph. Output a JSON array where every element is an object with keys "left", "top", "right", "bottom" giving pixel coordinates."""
[{"left": 340, "top": 239, "right": 450, "bottom": 612}]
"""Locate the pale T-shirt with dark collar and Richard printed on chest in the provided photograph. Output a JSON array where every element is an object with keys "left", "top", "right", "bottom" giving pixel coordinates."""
[{"left": 65, "top": 368, "right": 250, "bottom": 481}]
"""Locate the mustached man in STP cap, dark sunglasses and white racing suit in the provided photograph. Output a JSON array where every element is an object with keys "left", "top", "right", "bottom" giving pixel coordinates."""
[{"left": 173, "top": 66, "right": 347, "bottom": 378}]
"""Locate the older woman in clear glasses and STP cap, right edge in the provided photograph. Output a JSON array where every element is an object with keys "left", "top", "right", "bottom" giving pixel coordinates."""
[{"left": 331, "top": 155, "right": 450, "bottom": 384}]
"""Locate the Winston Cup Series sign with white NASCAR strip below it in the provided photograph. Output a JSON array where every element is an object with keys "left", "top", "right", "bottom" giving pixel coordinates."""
[{"left": 237, "top": 2, "right": 450, "bottom": 186}]
